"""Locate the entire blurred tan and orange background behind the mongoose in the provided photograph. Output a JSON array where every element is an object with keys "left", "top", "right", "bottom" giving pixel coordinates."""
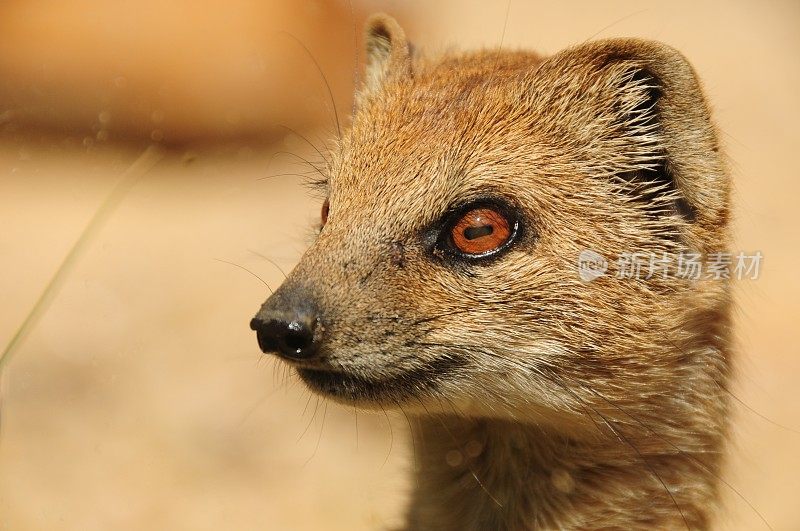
[{"left": 0, "top": 0, "right": 800, "bottom": 530}]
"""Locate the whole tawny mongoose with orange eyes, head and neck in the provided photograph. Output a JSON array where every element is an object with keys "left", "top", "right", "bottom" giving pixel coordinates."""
[{"left": 251, "top": 15, "right": 731, "bottom": 531}]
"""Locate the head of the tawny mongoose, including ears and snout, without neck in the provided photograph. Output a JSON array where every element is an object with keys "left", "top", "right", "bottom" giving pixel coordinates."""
[{"left": 251, "top": 16, "right": 728, "bottom": 438}]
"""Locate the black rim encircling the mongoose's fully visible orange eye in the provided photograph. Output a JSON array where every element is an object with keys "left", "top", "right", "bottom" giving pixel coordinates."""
[{"left": 434, "top": 197, "right": 522, "bottom": 263}]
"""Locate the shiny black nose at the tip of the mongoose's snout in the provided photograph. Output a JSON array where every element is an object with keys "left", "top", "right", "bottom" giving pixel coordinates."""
[{"left": 250, "top": 316, "right": 319, "bottom": 360}]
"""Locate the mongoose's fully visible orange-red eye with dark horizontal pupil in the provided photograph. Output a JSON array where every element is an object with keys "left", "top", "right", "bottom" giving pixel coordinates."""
[{"left": 450, "top": 207, "right": 513, "bottom": 256}]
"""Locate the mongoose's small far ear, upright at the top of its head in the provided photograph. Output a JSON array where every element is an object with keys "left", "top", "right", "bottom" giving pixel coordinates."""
[{"left": 364, "top": 13, "right": 411, "bottom": 93}]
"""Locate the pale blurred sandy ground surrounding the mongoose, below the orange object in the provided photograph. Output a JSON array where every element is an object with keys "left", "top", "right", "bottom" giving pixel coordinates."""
[{"left": 0, "top": 2, "right": 800, "bottom": 530}]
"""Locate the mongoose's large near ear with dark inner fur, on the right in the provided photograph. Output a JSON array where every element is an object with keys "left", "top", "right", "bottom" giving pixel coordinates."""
[{"left": 537, "top": 39, "right": 730, "bottom": 243}]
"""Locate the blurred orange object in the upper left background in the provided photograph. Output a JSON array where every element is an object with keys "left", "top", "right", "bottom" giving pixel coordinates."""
[{"left": 0, "top": 0, "right": 363, "bottom": 143}]
